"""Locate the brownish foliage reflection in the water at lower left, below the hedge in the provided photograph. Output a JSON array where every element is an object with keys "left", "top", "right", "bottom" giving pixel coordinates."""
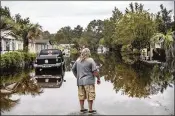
[{"left": 0, "top": 72, "right": 43, "bottom": 112}]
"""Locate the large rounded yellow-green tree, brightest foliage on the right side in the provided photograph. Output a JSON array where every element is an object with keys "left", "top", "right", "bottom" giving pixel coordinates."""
[{"left": 113, "top": 4, "right": 156, "bottom": 50}]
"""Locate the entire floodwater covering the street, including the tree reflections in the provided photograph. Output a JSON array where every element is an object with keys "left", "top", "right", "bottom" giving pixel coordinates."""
[{"left": 1, "top": 54, "right": 175, "bottom": 115}]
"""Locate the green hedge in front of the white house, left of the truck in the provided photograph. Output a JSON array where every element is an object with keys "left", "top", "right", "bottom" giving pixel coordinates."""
[{"left": 0, "top": 51, "right": 36, "bottom": 70}]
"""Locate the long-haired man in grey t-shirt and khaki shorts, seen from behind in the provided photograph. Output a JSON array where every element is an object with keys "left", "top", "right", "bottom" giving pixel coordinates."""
[{"left": 72, "top": 48, "right": 100, "bottom": 114}]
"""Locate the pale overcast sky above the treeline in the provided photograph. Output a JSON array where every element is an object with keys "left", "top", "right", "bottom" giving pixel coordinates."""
[{"left": 1, "top": 1, "right": 174, "bottom": 33}]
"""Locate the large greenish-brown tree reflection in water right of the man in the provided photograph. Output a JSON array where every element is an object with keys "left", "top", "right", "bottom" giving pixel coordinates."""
[{"left": 92, "top": 54, "right": 175, "bottom": 98}]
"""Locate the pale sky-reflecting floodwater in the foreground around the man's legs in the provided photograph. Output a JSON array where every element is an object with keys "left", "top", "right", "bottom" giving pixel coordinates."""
[{"left": 2, "top": 72, "right": 174, "bottom": 115}]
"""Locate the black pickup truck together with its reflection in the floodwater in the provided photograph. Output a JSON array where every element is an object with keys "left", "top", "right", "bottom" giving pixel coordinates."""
[{"left": 34, "top": 49, "right": 65, "bottom": 85}]
